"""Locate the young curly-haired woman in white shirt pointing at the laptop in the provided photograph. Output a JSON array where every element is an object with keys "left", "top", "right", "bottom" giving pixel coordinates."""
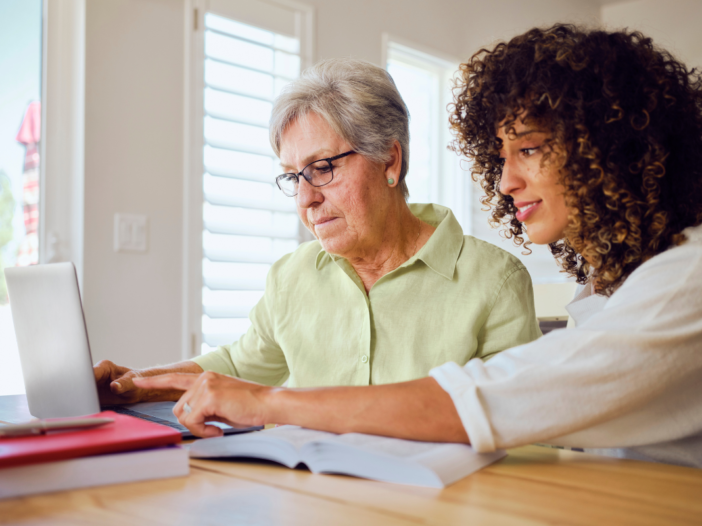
[{"left": 135, "top": 25, "right": 702, "bottom": 467}]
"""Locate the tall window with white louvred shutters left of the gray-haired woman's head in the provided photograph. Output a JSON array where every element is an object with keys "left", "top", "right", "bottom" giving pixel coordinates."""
[{"left": 190, "top": 1, "right": 311, "bottom": 356}]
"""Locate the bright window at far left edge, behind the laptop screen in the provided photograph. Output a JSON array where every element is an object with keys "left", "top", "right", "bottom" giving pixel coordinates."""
[{"left": 0, "top": 0, "right": 42, "bottom": 395}]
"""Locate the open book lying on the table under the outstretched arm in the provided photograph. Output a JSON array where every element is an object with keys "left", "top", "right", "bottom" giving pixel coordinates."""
[{"left": 190, "top": 426, "right": 507, "bottom": 488}]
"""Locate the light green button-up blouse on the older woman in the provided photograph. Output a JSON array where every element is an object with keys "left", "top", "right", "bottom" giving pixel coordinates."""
[{"left": 193, "top": 204, "right": 541, "bottom": 387}]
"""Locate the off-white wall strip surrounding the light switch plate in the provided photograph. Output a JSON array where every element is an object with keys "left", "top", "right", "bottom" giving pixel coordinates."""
[{"left": 83, "top": 0, "right": 184, "bottom": 367}]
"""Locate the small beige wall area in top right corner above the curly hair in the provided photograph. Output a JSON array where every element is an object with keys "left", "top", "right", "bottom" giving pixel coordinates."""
[{"left": 602, "top": 0, "right": 702, "bottom": 68}]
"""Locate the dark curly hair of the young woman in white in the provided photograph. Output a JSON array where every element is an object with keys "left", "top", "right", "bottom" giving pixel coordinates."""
[{"left": 449, "top": 24, "right": 702, "bottom": 294}]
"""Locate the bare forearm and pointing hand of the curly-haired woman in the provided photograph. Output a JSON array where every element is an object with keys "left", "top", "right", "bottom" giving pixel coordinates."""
[{"left": 134, "top": 372, "right": 469, "bottom": 443}]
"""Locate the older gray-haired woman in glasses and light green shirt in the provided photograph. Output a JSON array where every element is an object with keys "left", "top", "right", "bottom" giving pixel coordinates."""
[{"left": 95, "top": 60, "right": 540, "bottom": 403}]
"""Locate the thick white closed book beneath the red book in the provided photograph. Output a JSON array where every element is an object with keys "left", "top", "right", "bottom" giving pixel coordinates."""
[{"left": 0, "top": 444, "right": 190, "bottom": 499}]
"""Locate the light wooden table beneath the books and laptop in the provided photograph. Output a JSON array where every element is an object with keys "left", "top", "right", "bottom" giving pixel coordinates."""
[{"left": 0, "top": 398, "right": 702, "bottom": 526}]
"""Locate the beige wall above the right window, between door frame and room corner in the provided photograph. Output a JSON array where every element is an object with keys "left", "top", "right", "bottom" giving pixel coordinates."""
[{"left": 301, "top": 0, "right": 600, "bottom": 64}]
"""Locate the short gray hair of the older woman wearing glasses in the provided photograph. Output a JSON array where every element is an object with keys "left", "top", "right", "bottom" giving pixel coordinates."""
[{"left": 270, "top": 59, "right": 409, "bottom": 199}]
